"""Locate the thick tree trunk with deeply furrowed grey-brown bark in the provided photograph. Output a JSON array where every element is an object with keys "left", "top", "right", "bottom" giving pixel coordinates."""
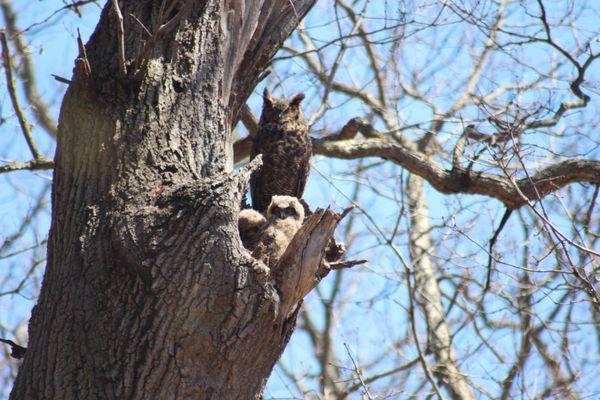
[{"left": 11, "top": 0, "right": 318, "bottom": 399}]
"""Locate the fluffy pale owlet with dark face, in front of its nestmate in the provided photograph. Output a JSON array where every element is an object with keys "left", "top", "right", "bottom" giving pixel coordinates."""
[{"left": 252, "top": 196, "right": 304, "bottom": 269}]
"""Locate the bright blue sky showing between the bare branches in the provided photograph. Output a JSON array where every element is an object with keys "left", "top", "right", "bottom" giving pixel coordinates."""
[{"left": 0, "top": 0, "right": 600, "bottom": 397}]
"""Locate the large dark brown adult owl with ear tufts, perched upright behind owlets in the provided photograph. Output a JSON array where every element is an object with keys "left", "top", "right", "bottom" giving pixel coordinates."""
[{"left": 250, "top": 89, "right": 312, "bottom": 212}]
